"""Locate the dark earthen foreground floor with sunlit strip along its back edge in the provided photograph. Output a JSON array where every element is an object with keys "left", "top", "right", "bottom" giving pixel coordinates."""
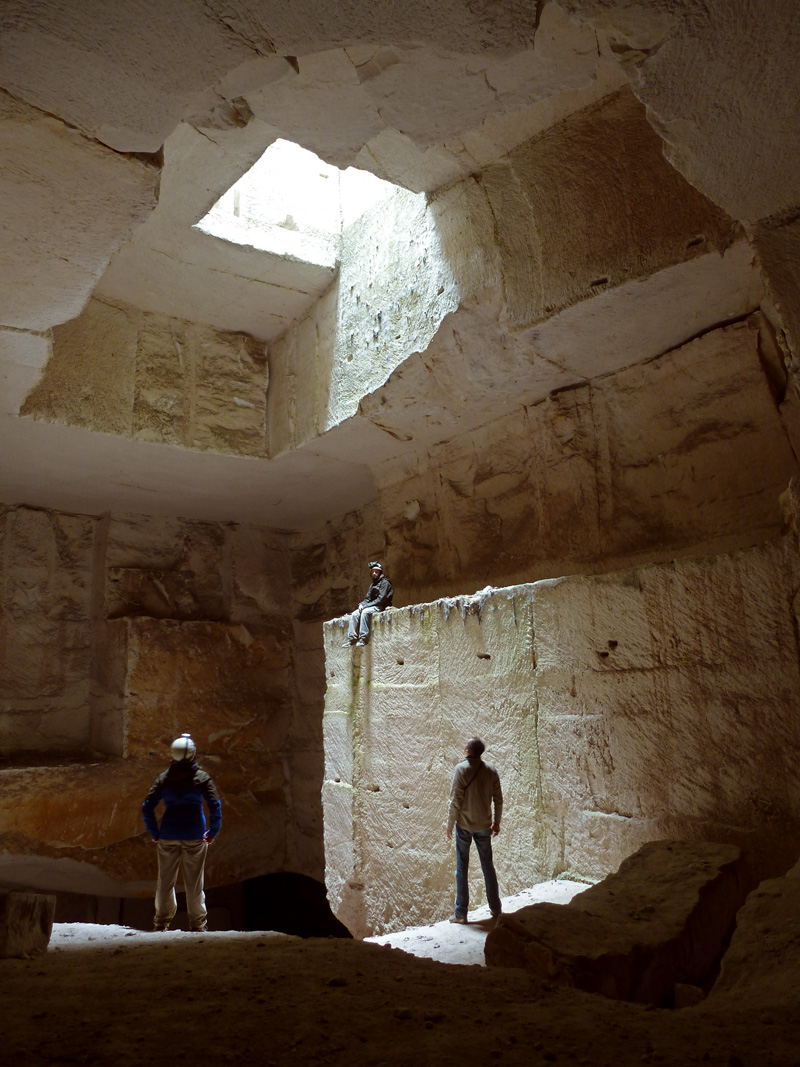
[{"left": 0, "top": 883, "right": 800, "bottom": 1067}]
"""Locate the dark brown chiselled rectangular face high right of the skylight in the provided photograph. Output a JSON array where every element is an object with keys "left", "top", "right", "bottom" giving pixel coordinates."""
[{"left": 481, "top": 92, "right": 733, "bottom": 328}]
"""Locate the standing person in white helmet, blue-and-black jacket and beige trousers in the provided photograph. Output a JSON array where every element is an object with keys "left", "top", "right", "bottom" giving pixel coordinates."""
[{"left": 142, "top": 734, "right": 222, "bottom": 933}]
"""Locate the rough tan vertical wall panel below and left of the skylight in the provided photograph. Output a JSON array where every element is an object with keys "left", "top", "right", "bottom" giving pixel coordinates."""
[{"left": 20, "top": 300, "right": 269, "bottom": 456}]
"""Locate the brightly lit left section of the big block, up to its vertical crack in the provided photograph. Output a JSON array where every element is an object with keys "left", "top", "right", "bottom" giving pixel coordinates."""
[{"left": 323, "top": 587, "right": 543, "bottom": 937}]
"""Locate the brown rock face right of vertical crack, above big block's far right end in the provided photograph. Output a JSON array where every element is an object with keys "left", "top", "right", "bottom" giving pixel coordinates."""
[{"left": 592, "top": 316, "right": 796, "bottom": 551}]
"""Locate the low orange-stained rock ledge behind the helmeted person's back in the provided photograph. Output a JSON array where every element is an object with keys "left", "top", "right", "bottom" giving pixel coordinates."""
[{"left": 0, "top": 725, "right": 296, "bottom": 895}]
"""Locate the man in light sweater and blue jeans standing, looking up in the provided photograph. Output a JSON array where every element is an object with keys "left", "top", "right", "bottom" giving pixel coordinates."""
[{"left": 447, "top": 737, "right": 502, "bottom": 923}]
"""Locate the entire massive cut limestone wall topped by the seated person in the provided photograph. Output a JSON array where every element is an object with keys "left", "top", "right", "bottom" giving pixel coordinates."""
[{"left": 323, "top": 535, "right": 800, "bottom": 936}]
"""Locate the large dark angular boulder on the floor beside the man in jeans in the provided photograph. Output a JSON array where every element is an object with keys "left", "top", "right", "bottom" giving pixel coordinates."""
[{"left": 485, "top": 841, "right": 748, "bottom": 1005}]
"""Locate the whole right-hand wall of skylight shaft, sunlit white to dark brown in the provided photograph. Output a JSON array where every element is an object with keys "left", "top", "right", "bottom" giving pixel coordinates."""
[{"left": 269, "top": 91, "right": 738, "bottom": 465}]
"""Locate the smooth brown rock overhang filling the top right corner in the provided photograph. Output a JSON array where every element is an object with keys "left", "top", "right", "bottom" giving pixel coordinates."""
[{"left": 558, "top": 0, "right": 800, "bottom": 227}]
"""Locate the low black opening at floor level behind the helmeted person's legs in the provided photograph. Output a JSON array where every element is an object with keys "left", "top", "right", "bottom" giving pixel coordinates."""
[{"left": 46, "top": 872, "right": 352, "bottom": 938}]
